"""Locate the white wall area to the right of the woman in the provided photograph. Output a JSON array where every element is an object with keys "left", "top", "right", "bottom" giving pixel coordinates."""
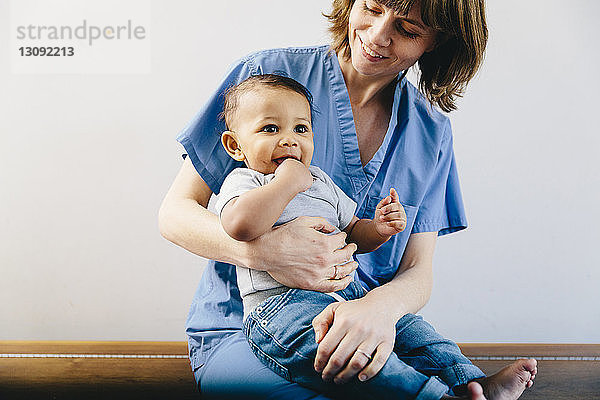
[{"left": 424, "top": 0, "right": 600, "bottom": 343}]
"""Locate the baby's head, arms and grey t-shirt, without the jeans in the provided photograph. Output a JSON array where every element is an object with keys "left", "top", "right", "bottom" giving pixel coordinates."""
[{"left": 216, "top": 75, "right": 406, "bottom": 317}]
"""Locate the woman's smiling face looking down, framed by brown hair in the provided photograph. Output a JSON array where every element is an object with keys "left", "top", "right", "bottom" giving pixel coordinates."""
[{"left": 348, "top": 0, "right": 435, "bottom": 78}]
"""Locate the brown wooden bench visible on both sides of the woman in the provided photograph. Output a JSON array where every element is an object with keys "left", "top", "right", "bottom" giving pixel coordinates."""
[{"left": 0, "top": 341, "right": 600, "bottom": 400}]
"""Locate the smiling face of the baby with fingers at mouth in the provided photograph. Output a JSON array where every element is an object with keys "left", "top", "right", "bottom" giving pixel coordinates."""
[{"left": 231, "top": 87, "right": 314, "bottom": 174}]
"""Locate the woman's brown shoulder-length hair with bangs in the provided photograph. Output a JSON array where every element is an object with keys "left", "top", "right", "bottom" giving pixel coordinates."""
[{"left": 324, "top": 0, "right": 488, "bottom": 112}]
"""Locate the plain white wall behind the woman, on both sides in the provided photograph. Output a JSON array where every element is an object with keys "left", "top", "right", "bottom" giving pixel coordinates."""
[{"left": 0, "top": 0, "right": 600, "bottom": 342}]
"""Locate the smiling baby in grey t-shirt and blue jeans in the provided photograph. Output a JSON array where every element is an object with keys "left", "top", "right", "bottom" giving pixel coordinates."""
[{"left": 216, "top": 74, "right": 536, "bottom": 399}]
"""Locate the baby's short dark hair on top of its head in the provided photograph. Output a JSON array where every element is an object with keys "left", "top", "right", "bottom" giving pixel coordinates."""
[{"left": 221, "top": 74, "right": 313, "bottom": 129}]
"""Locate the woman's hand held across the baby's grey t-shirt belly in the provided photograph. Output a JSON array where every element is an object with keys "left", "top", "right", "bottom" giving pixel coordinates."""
[{"left": 246, "top": 217, "right": 358, "bottom": 292}]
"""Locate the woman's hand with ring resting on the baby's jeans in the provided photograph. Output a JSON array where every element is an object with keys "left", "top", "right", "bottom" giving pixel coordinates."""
[{"left": 313, "top": 294, "right": 397, "bottom": 384}]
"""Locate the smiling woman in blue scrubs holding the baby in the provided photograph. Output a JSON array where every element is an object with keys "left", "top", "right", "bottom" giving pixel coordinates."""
[{"left": 159, "top": 0, "right": 536, "bottom": 399}]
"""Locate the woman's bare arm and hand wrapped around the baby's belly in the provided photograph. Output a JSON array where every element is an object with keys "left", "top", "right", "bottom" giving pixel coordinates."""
[{"left": 158, "top": 157, "right": 358, "bottom": 292}]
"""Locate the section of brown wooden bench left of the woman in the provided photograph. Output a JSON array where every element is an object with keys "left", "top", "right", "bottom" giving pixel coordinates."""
[{"left": 0, "top": 341, "right": 199, "bottom": 400}]
